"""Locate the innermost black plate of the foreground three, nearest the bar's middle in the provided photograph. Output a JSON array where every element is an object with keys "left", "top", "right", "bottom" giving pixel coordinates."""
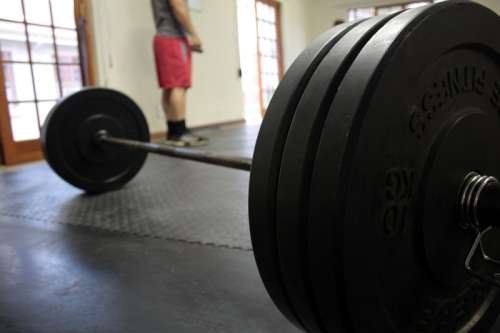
[{"left": 249, "top": 24, "right": 353, "bottom": 327}]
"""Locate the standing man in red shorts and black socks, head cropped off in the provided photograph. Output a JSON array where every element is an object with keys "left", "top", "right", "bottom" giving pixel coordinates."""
[{"left": 152, "top": 0, "right": 207, "bottom": 147}]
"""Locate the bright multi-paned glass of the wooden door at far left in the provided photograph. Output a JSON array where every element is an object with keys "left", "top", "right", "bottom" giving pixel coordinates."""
[{"left": 0, "top": 0, "right": 82, "bottom": 142}]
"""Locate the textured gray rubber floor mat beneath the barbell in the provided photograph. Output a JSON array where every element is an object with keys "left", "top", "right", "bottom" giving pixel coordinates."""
[{"left": 0, "top": 129, "right": 254, "bottom": 250}]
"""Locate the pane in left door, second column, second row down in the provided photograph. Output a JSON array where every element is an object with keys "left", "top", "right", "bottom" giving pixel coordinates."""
[{"left": 28, "top": 25, "right": 56, "bottom": 62}]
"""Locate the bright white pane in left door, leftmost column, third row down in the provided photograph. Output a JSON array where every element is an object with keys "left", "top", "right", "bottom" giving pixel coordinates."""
[{"left": 3, "top": 64, "right": 35, "bottom": 101}]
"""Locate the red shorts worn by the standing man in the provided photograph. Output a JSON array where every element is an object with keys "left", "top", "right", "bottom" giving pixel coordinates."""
[{"left": 153, "top": 35, "right": 191, "bottom": 89}]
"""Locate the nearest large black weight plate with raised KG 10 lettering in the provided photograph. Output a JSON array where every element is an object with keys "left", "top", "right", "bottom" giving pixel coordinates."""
[{"left": 309, "top": 1, "right": 500, "bottom": 333}]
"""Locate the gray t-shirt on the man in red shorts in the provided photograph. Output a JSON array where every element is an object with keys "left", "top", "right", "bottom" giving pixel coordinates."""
[{"left": 151, "top": 0, "right": 187, "bottom": 37}]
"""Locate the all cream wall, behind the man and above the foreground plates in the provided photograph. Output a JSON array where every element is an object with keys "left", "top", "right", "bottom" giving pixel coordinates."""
[{"left": 88, "top": 0, "right": 500, "bottom": 132}]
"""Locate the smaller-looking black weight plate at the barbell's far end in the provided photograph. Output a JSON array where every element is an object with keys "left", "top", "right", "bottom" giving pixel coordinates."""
[{"left": 41, "top": 88, "right": 149, "bottom": 193}]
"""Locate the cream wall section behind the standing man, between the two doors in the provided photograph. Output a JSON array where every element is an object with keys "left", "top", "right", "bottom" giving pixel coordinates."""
[{"left": 92, "top": 0, "right": 244, "bottom": 132}]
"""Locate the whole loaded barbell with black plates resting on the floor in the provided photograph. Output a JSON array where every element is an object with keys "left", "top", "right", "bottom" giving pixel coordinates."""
[{"left": 42, "top": 0, "right": 500, "bottom": 333}]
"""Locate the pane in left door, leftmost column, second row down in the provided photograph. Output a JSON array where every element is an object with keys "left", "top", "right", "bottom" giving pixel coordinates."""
[{"left": 0, "top": 22, "right": 29, "bottom": 61}]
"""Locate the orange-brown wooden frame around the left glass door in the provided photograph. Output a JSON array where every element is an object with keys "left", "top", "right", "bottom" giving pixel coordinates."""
[{"left": 0, "top": 0, "right": 96, "bottom": 165}]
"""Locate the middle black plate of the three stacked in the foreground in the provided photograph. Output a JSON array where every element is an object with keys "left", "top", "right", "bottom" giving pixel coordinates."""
[{"left": 276, "top": 15, "right": 393, "bottom": 332}]
